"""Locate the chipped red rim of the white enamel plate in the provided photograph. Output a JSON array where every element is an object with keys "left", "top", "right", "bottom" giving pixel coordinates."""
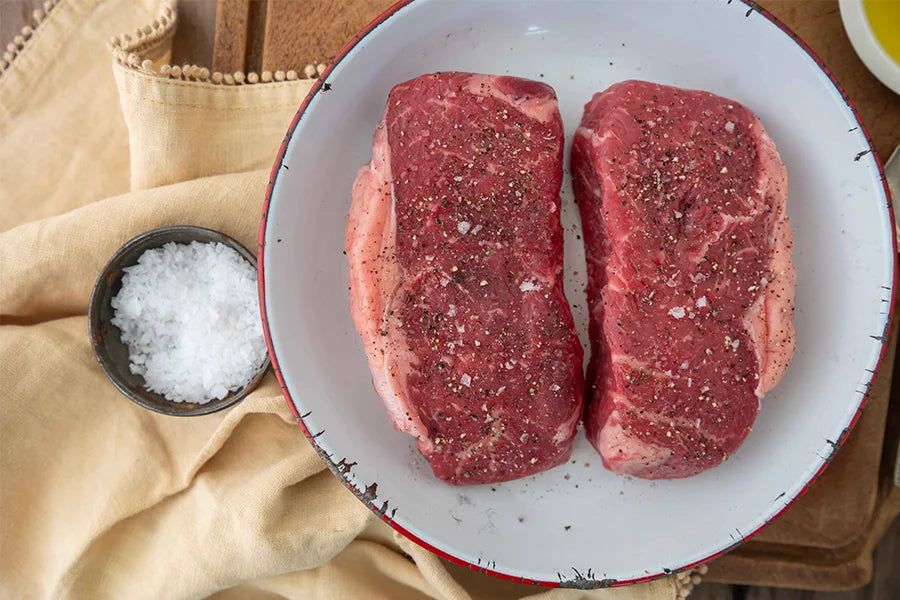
[{"left": 257, "top": 0, "right": 898, "bottom": 587}]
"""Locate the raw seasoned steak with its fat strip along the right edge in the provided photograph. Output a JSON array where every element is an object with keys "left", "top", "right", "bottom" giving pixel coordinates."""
[{"left": 572, "top": 81, "right": 796, "bottom": 479}]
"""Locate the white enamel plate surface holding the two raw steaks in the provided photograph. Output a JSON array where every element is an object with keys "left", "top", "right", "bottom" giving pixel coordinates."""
[{"left": 259, "top": 0, "right": 896, "bottom": 587}]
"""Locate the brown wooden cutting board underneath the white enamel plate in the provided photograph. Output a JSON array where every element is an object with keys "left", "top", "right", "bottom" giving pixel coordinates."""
[{"left": 213, "top": 0, "right": 900, "bottom": 590}]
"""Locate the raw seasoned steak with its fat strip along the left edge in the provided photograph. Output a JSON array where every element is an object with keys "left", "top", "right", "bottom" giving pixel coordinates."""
[{"left": 346, "top": 73, "right": 584, "bottom": 484}]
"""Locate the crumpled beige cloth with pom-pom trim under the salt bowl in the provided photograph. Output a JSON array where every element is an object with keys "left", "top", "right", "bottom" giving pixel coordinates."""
[{"left": 0, "top": 0, "right": 690, "bottom": 600}]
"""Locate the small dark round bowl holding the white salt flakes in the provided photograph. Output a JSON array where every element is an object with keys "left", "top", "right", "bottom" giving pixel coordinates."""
[{"left": 88, "top": 226, "right": 269, "bottom": 417}]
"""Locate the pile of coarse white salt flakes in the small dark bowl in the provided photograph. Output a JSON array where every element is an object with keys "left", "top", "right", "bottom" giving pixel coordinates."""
[{"left": 112, "top": 242, "right": 266, "bottom": 404}]
